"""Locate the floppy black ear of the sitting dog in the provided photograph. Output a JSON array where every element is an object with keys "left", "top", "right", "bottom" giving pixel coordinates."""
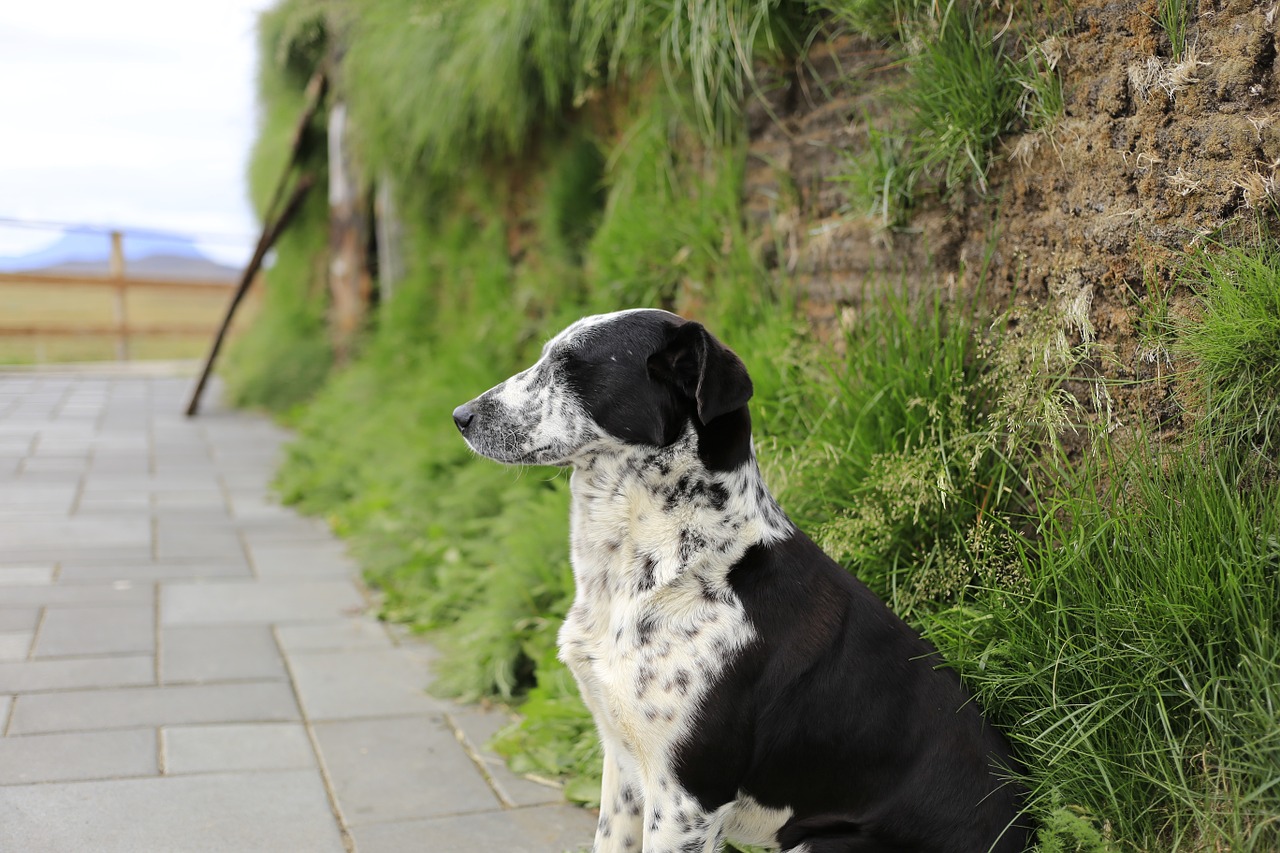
[{"left": 649, "top": 321, "right": 753, "bottom": 424}]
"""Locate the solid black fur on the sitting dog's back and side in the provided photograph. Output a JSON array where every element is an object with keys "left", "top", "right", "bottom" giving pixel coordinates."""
[{"left": 678, "top": 530, "right": 1027, "bottom": 853}]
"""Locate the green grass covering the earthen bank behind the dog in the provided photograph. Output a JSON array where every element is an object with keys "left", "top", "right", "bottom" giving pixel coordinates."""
[{"left": 229, "top": 0, "right": 1280, "bottom": 852}]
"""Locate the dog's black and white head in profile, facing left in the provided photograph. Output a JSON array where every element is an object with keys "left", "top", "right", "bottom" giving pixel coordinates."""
[{"left": 453, "top": 309, "right": 751, "bottom": 467}]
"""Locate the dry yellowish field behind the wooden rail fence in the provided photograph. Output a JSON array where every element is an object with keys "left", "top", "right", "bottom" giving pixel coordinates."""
[{"left": 0, "top": 277, "right": 256, "bottom": 364}]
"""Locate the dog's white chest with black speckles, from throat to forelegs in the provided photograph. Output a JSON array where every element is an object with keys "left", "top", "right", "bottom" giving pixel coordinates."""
[{"left": 561, "top": 458, "right": 754, "bottom": 761}]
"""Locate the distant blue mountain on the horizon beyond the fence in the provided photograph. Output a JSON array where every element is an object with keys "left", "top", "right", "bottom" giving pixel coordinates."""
[{"left": 0, "top": 225, "right": 239, "bottom": 279}]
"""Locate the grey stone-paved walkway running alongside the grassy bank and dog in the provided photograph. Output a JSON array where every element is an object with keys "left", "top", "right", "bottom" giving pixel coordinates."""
[{"left": 0, "top": 373, "right": 595, "bottom": 853}]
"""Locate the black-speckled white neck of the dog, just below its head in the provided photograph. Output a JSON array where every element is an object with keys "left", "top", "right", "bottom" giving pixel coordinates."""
[{"left": 571, "top": 417, "right": 792, "bottom": 593}]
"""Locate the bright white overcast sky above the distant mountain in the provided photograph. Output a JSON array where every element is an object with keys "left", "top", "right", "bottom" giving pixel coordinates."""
[{"left": 0, "top": 0, "right": 271, "bottom": 265}]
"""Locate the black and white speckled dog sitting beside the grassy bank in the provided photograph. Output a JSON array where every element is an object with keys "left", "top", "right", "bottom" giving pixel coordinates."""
[{"left": 453, "top": 310, "right": 1028, "bottom": 853}]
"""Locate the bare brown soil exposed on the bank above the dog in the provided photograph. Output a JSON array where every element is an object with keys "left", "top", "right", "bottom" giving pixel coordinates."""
[{"left": 746, "top": 0, "right": 1280, "bottom": 438}]
